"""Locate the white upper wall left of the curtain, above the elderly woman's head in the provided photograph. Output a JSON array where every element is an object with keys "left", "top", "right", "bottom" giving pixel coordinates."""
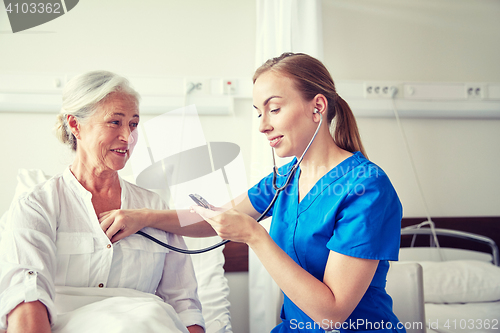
[{"left": 0, "top": 0, "right": 255, "bottom": 76}]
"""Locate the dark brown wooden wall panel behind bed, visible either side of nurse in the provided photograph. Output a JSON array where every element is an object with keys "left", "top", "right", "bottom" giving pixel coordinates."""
[{"left": 224, "top": 216, "right": 500, "bottom": 272}]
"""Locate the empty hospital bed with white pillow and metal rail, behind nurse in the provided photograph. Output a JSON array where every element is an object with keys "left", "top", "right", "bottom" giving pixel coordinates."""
[{"left": 398, "top": 217, "right": 500, "bottom": 333}]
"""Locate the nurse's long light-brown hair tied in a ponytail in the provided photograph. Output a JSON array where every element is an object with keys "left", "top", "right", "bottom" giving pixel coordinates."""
[{"left": 253, "top": 53, "right": 367, "bottom": 157}]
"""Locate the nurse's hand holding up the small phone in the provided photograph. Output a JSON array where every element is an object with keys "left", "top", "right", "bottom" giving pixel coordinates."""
[{"left": 190, "top": 206, "right": 267, "bottom": 244}]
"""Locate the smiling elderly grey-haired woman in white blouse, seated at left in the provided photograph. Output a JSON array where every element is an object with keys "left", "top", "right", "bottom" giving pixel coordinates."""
[{"left": 0, "top": 71, "right": 204, "bottom": 333}]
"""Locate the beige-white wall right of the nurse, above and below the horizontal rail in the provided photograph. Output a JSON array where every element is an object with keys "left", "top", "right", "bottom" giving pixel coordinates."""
[{"left": 323, "top": 0, "right": 500, "bottom": 217}]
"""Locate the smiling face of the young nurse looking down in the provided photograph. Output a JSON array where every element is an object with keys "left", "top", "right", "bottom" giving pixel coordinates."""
[{"left": 253, "top": 71, "right": 317, "bottom": 157}]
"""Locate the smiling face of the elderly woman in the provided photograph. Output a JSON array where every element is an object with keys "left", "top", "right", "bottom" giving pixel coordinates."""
[{"left": 77, "top": 93, "right": 139, "bottom": 171}]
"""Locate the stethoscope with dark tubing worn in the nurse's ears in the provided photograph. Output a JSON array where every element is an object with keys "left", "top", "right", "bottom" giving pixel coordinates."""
[{"left": 136, "top": 109, "right": 323, "bottom": 254}]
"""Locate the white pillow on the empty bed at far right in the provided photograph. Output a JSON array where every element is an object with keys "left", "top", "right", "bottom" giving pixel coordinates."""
[{"left": 419, "top": 260, "right": 500, "bottom": 303}]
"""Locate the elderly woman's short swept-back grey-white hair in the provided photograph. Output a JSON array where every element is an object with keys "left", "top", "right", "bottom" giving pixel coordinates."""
[{"left": 55, "top": 71, "right": 140, "bottom": 151}]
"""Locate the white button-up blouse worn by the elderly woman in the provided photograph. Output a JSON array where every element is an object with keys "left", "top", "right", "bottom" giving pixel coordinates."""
[{"left": 0, "top": 168, "right": 204, "bottom": 329}]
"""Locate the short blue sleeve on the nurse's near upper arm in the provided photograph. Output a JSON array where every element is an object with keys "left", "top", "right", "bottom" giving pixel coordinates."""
[{"left": 327, "top": 174, "right": 402, "bottom": 260}]
